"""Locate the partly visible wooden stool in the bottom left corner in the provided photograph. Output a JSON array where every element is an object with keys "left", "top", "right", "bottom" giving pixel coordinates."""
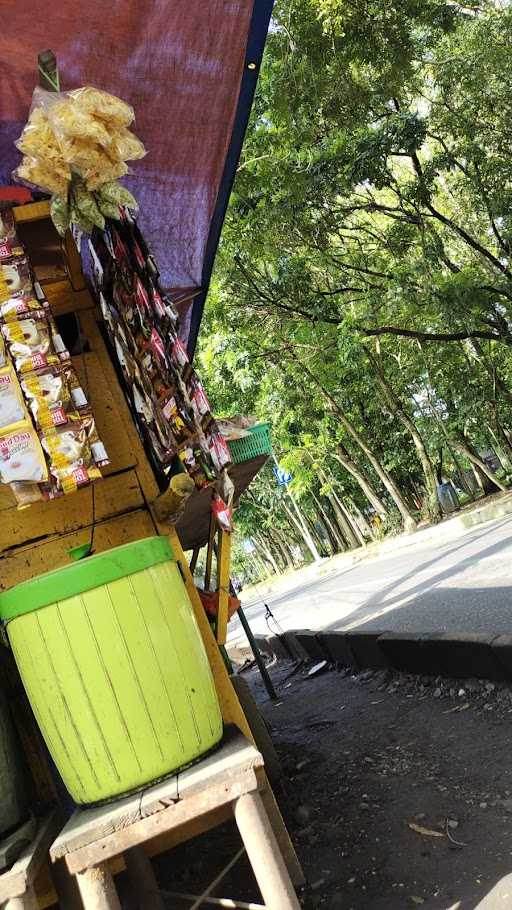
[{"left": 0, "top": 813, "right": 59, "bottom": 910}]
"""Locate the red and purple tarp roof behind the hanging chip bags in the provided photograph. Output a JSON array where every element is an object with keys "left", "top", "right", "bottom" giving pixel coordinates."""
[{"left": 0, "top": 0, "right": 258, "bottom": 288}]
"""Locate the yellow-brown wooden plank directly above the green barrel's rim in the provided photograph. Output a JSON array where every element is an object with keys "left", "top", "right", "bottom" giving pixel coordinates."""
[{"left": 0, "top": 509, "right": 158, "bottom": 590}]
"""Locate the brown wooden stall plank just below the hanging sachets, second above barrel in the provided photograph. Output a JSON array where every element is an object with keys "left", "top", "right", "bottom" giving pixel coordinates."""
[{"left": 0, "top": 469, "right": 144, "bottom": 558}]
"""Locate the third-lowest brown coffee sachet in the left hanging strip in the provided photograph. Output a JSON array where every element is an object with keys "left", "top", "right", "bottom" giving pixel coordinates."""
[{"left": 2, "top": 313, "right": 69, "bottom": 373}]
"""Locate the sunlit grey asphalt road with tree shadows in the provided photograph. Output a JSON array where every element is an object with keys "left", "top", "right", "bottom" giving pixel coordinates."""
[{"left": 229, "top": 516, "right": 512, "bottom": 644}]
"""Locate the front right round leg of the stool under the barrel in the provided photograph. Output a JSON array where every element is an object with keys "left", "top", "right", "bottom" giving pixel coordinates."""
[{"left": 235, "top": 791, "right": 300, "bottom": 910}]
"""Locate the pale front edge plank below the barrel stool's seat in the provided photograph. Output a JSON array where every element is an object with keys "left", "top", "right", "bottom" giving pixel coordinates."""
[{"left": 66, "top": 771, "right": 257, "bottom": 875}]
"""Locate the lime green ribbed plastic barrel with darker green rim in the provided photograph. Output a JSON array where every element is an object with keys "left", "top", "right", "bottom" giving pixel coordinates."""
[{"left": 0, "top": 537, "right": 222, "bottom": 804}]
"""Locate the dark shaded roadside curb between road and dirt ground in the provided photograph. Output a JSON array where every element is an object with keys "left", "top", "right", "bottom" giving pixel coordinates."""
[{"left": 248, "top": 628, "right": 512, "bottom": 681}]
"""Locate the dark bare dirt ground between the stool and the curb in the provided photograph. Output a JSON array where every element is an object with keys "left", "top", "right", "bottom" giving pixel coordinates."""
[{"left": 144, "top": 665, "right": 512, "bottom": 910}]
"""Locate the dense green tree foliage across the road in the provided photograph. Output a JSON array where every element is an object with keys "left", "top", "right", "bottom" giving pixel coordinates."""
[{"left": 196, "top": 0, "right": 512, "bottom": 572}]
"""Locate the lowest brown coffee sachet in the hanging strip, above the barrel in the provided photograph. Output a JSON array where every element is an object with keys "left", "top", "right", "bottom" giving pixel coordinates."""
[{"left": 41, "top": 417, "right": 108, "bottom": 494}]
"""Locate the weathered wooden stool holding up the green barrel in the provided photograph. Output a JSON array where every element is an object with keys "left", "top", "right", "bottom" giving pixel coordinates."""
[{"left": 50, "top": 728, "right": 300, "bottom": 910}]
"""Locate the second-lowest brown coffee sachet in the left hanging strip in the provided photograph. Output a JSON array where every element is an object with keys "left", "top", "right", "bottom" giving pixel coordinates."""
[{"left": 21, "top": 366, "right": 88, "bottom": 429}]
